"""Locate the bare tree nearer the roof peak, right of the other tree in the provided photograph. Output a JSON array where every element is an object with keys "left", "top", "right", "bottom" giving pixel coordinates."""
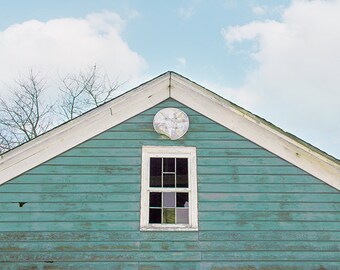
[{"left": 58, "top": 65, "right": 123, "bottom": 120}]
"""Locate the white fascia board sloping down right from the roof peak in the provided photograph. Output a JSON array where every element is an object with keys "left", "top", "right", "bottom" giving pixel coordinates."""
[{"left": 170, "top": 73, "right": 340, "bottom": 190}]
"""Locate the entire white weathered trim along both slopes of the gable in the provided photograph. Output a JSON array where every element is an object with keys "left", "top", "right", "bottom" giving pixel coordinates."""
[{"left": 0, "top": 72, "right": 340, "bottom": 190}]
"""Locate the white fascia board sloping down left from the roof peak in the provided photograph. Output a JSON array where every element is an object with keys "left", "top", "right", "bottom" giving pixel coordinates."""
[{"left": 0, "top": 73, "right": 170, "bottom": 185}]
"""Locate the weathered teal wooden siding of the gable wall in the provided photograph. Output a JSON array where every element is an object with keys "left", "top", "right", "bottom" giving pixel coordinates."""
[{"left": 0, "top": 100, "right": 340, "bottom": 270}]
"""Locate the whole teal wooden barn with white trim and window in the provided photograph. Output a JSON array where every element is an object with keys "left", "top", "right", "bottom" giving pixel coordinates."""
[{"left": 0, "top": 72, "right": 340, "bottom": 270}]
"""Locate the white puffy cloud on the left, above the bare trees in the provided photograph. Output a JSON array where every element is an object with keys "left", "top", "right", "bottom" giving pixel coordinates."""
[{"left": 0, "top": 12, "right": 146, "bottom": 98}]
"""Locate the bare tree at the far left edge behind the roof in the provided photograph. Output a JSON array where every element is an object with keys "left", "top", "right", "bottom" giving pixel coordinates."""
[{"left": 0, "top": 70, "right": 52, "bottom": 153}]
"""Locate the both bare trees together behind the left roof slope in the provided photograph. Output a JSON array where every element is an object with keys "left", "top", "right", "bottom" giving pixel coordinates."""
[{"left": 0, "top": 65, "right": 122, "bottom": 153}]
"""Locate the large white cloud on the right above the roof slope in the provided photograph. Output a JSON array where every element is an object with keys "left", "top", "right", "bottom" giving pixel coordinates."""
[{"left": 223, "top": 0, "right": 340, "bottom": 157}]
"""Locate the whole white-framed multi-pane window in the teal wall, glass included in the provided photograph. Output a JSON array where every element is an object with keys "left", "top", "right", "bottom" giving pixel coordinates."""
[{"left": 140, "top": 146, "right": 198, "bottom": 230}]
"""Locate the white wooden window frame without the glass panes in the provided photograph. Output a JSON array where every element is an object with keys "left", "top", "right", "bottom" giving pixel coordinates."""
[{"left": 140, "top": 146, "right": 198, "bottom": 231}]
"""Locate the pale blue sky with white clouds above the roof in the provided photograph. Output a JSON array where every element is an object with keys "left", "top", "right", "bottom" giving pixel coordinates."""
[{"left": 0, "top": 0, "right": 340, "bottom": 159}]
